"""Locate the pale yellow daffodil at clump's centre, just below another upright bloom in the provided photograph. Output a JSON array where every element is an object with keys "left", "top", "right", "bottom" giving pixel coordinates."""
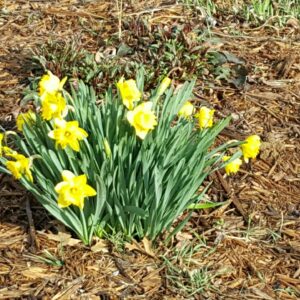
[{"left": 127, "top": 102, "right": 157, "bottom": 140}]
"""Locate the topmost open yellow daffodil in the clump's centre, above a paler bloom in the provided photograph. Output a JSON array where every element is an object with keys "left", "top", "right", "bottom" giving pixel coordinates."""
[{"left": 117, "top": 77, "right": 142, "bottom": 110}]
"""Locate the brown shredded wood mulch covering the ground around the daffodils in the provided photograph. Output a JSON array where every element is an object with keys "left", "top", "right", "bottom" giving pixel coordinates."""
[{"left": 0, "top": 0, "right": 300, "bottom": 299}]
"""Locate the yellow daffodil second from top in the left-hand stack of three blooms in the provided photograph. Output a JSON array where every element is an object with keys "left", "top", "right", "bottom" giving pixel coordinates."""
[{"left": 41, "top": 93, "right": 67, "bottom": 121}]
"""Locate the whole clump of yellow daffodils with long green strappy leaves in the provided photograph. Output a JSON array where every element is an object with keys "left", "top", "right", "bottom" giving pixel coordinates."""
[{"left": 0, "top": 71, "right": 260, "bottom": 244}]
